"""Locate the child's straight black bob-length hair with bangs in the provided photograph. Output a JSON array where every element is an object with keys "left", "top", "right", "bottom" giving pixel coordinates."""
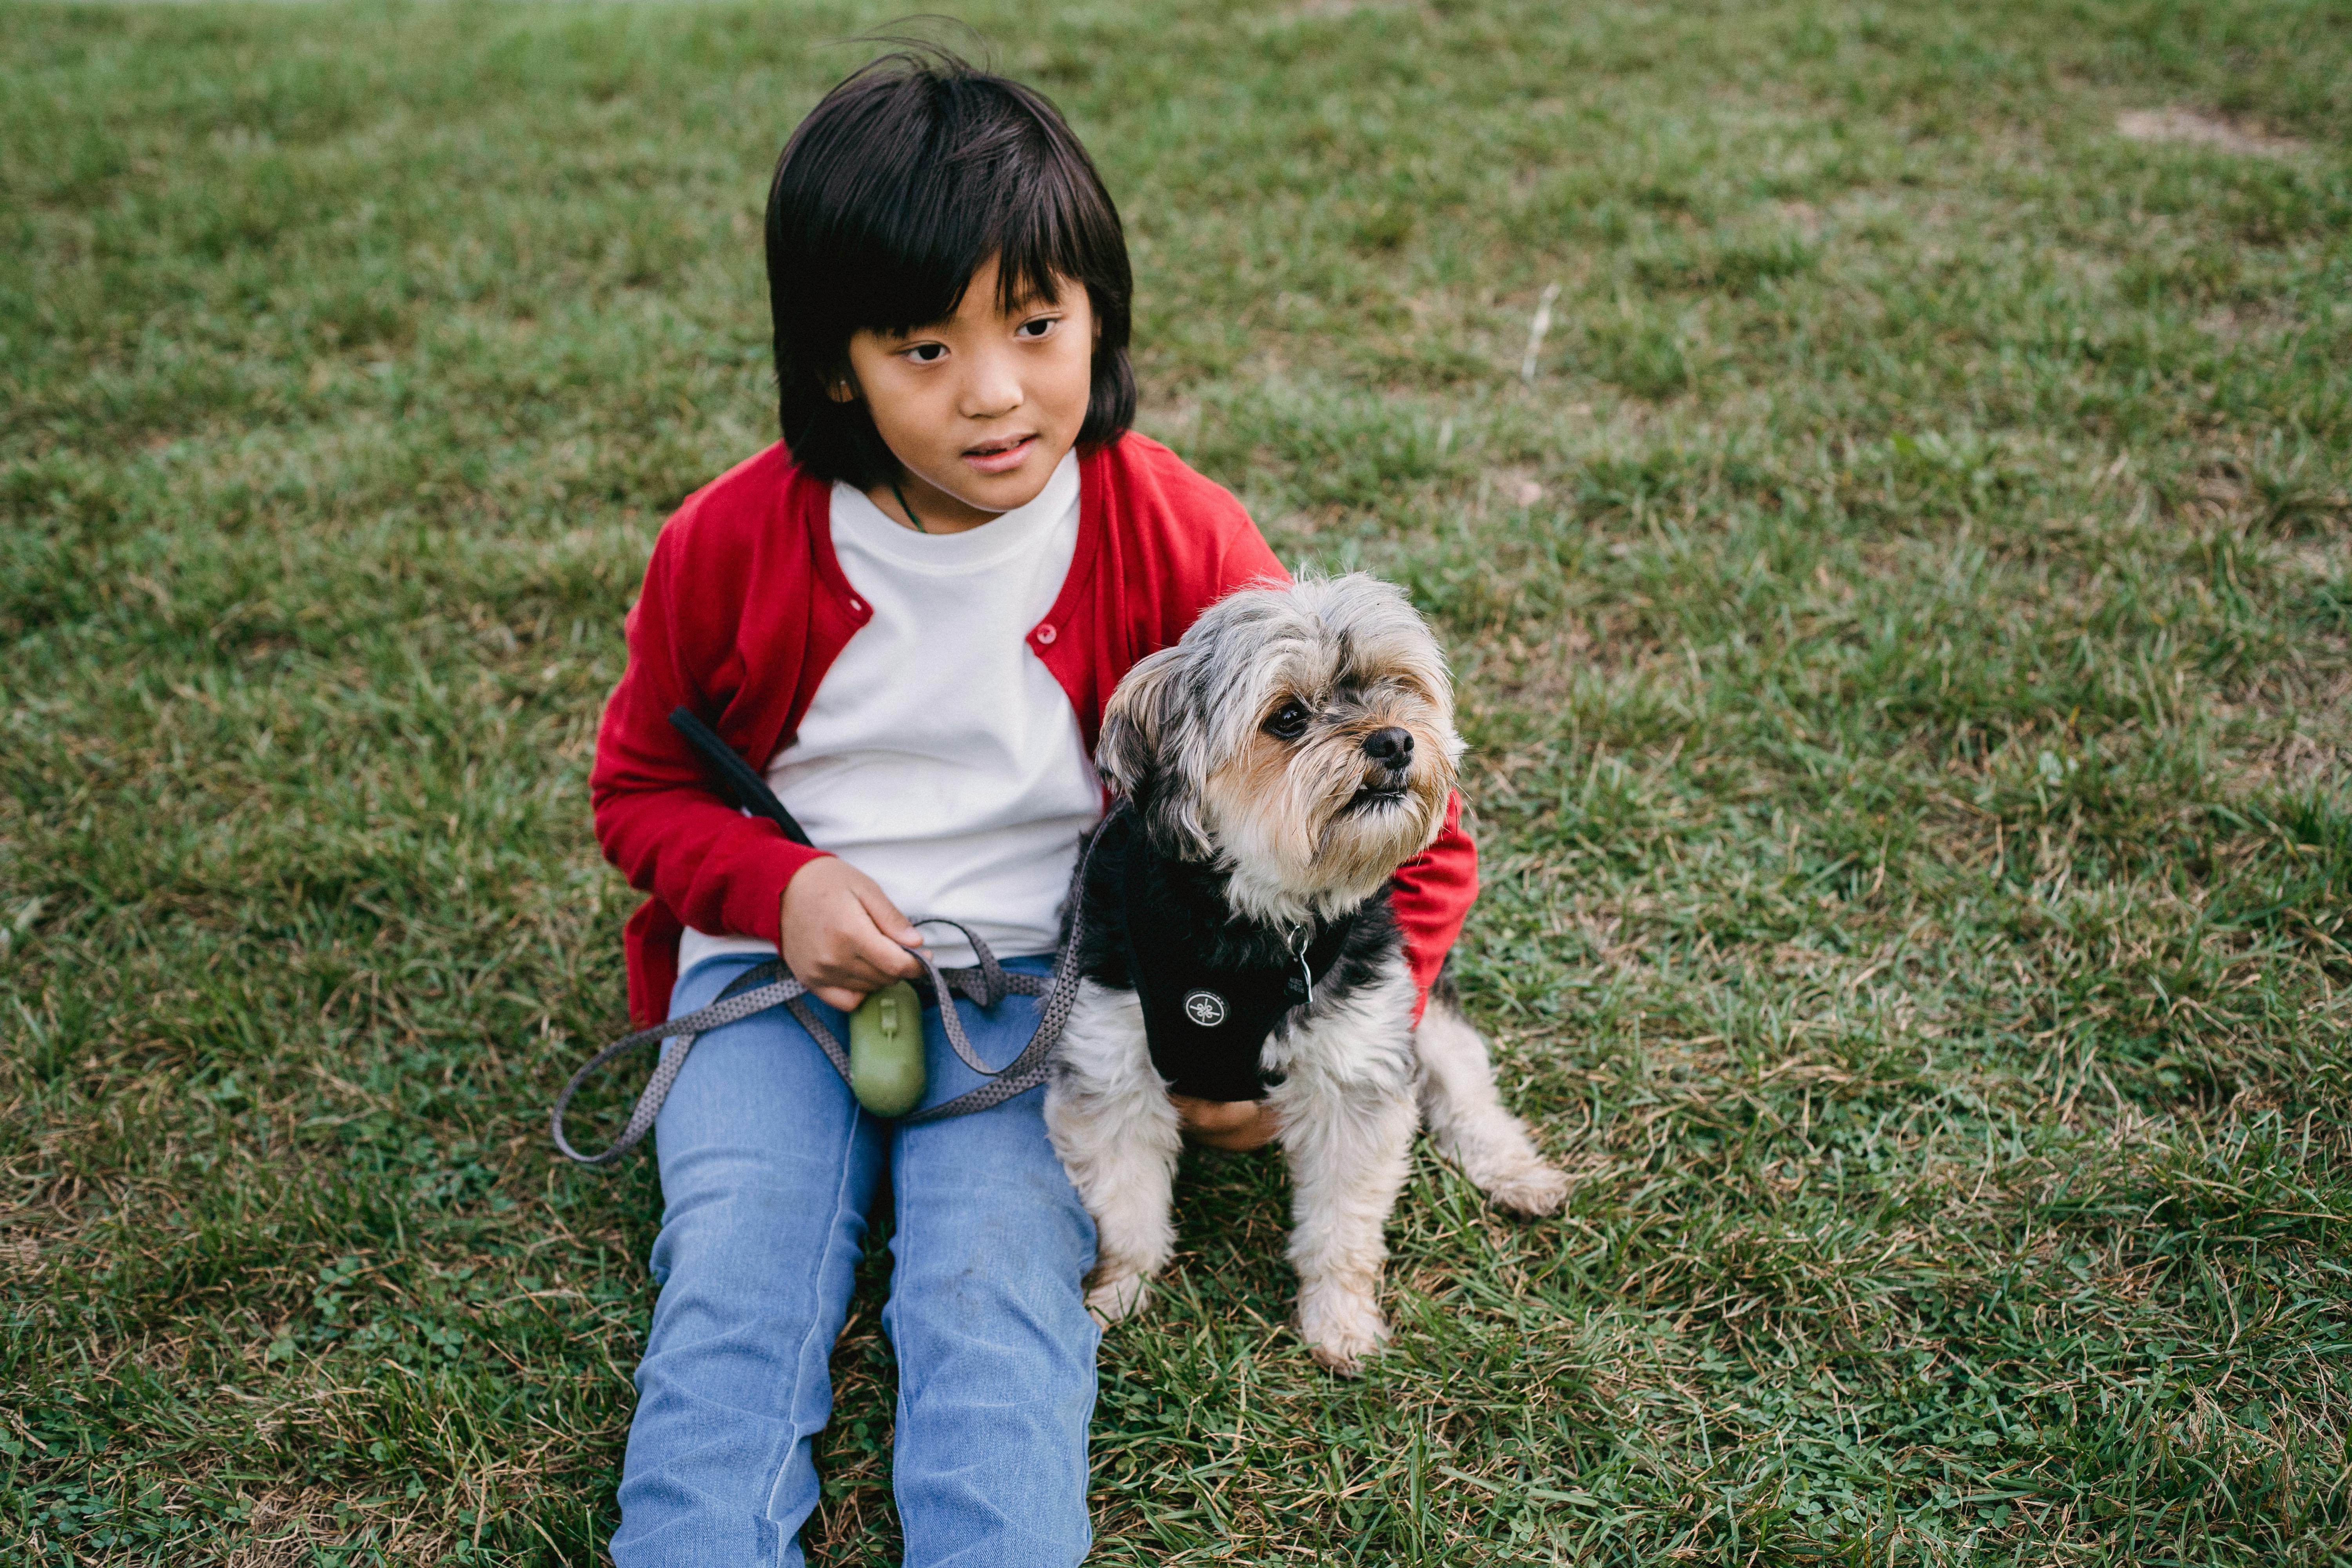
[{"left": 767, "top": 49, "right": 1136, "bottom": 489}]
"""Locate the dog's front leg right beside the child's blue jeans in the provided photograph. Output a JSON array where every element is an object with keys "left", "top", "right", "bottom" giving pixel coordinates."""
[{"left": 1044, "top": 980, "right": 1183, "bottom": 1323}]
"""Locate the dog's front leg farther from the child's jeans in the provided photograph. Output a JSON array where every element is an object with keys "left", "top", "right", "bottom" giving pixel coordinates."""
[{"left": 1272, "top": 1020, "right": 1421, "bottom": 1375}]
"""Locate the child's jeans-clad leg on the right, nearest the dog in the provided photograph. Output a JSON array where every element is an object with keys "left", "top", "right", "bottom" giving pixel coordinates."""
[{"left": 882, "top": 962, "right": 1101, "bottom": 1568}]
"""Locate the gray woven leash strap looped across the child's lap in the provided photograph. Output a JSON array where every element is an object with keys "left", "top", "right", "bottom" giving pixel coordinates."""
[{"left": 548, "top": 835, "right": 1101, "bottom": 1166}]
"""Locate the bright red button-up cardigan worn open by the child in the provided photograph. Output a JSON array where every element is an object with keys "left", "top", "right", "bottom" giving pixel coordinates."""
[{"left": 588, "top": 435, "right": 1477, "bottom": 1027}]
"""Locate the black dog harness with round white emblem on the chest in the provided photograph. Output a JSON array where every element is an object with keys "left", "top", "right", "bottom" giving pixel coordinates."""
[{"left": 1098, "top": 811, "right": 1357, "bottom": 1100}]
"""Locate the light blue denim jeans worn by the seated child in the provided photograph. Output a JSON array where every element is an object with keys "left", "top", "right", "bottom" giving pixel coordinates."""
[{"left": 612, "top": 955, "right": 1098, "bottom": 1568}]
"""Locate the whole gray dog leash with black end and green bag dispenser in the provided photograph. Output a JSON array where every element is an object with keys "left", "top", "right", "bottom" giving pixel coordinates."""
[{"left": 548, "top": 708, "right": 1101, "bottom": 1166}]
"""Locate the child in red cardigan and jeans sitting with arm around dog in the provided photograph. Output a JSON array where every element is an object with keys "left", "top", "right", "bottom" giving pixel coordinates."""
[{"left": 593, "top": 56, "right": 1477, "bottom": 1568}]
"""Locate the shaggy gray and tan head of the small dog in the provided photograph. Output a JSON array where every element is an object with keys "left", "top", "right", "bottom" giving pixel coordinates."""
[{"left": 1096, "top": 573, "right": 1463, "bottom": 919}]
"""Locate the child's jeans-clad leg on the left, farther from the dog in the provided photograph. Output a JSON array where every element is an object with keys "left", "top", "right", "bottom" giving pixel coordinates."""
[{"left": 612, "top": 959, "right": 884, "bottom": 1568}]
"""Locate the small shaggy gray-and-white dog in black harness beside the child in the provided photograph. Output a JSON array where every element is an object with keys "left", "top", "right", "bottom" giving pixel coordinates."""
[{"left": 1044, "top": 573, "right": 1566, "bottom": 1373}]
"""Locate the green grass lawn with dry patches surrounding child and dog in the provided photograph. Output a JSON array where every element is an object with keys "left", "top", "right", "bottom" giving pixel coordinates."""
[{"left": 0, "top": 0, "right": 2352, "bottom": 1566}]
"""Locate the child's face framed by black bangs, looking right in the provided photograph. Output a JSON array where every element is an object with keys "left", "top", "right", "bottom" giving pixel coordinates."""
[{"left": 844, "top": 256, "right": 1094, "bottom": 531}]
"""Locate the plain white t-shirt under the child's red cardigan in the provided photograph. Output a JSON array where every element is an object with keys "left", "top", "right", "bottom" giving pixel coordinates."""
[{"left": 677, "top": 454, "right": 1103, "bottom": 973}]
